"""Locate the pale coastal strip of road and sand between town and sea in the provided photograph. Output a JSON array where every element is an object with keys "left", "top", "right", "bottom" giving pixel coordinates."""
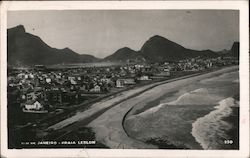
[{"left": 9, "top": 66, "right": 238, "bottom": 149}]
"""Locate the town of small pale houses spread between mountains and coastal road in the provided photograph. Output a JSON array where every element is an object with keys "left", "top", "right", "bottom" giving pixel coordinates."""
[{"left": 8, "top": 57, "right": 238, "bottom": 146}]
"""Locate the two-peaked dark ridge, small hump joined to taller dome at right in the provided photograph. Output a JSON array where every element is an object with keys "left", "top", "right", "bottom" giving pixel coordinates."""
[{"left": 104, "top": 35, "right": 219, "bottom": 62}]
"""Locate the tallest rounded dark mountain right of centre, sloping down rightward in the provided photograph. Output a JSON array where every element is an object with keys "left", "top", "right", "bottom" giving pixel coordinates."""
[{"left": 140, "top": 35, "right": 218, "bottom": 62}]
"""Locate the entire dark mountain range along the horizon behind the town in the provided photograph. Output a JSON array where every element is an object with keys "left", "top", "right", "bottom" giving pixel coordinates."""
[{"left": 7, "top": 25, "right": 239, "bottom": 65}]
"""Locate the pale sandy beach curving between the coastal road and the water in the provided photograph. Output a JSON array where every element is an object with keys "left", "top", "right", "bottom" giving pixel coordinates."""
[{"left": 88, "top": 66, "right": 238, "bottom": 148}]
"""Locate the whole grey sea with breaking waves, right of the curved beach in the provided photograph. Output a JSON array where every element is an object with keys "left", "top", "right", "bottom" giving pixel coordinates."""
[{"left": 124, "top": 69, "right": 239, "bottom": 149}]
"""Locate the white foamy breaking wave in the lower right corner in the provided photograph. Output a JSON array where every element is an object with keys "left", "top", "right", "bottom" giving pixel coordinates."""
[{"left": 191, "top": 97, "right": 239, "bottom": 149}]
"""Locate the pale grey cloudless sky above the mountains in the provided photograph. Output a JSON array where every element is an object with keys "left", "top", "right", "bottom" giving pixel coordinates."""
[{"left": 7, "top": 10, "right": 239, "bottom": 58}]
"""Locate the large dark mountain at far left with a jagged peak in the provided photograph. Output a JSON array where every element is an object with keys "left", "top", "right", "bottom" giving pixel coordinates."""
[{"left": 7, "top": 25, "right": 99, "bottom": 65}]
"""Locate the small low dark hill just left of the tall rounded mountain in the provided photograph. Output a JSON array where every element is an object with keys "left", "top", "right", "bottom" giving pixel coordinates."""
[{"left": 104, "top": 47, "right": 143, "bottom": 61}]
